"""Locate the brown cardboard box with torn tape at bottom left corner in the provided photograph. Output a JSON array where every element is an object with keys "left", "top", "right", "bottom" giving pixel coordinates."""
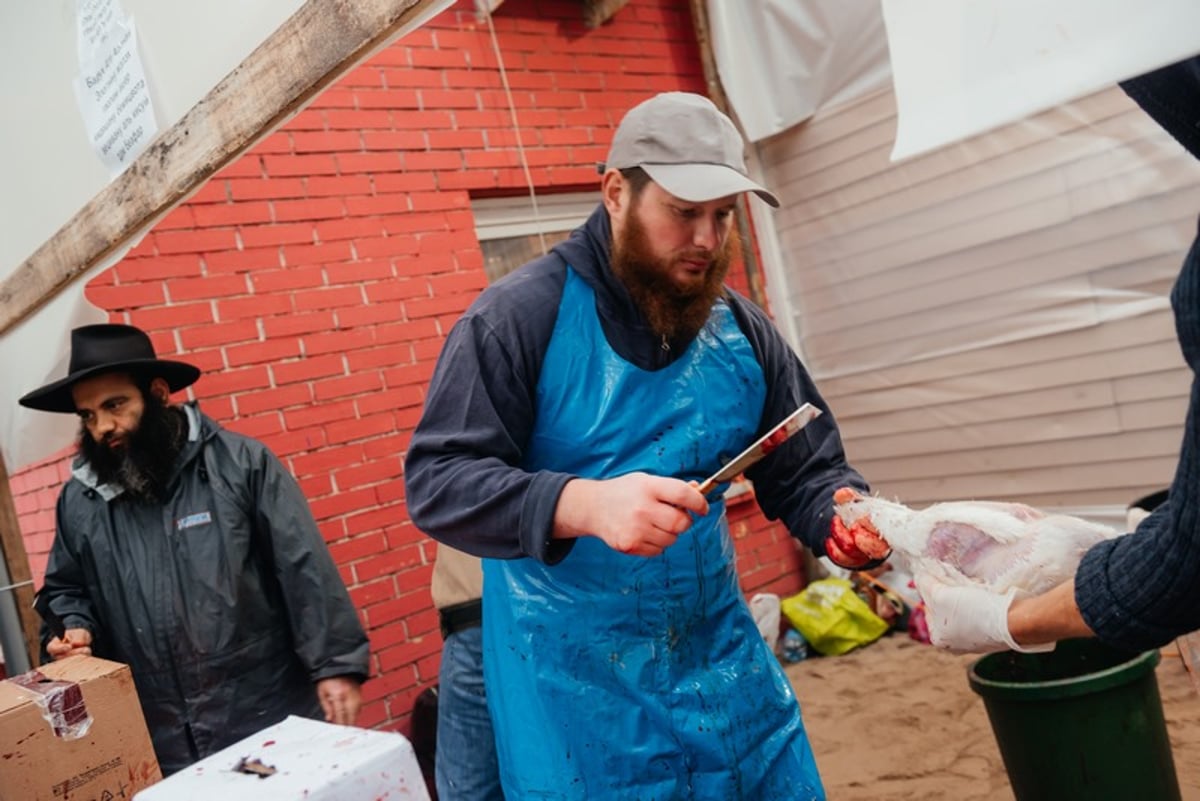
[{"left": 0, "top": 656, "right": 162, "bottom": 801}]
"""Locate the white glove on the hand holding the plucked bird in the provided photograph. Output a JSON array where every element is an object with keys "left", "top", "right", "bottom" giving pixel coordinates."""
[{"left": 916, "top": 574, "right": 1056, "bottom": 654}]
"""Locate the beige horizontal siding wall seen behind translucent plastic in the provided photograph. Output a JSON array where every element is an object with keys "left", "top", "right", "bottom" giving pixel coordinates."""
[{"left": 758, "top": 89, "right": 1200, "bottom": 510}]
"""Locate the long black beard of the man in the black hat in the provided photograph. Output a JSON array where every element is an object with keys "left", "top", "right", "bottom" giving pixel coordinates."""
[{"left": 79, "top": 392, "right": 187, "bottom": 504}]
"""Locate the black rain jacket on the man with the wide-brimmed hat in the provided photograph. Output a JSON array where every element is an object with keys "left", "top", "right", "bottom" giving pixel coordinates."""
[{"left": 42, "top": 405, "right": 370, "bottom": 775}]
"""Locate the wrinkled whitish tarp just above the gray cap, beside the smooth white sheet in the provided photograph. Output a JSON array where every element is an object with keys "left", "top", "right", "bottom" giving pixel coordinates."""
[{"left": 708, "top": 0, "right": 892, "bottom": 141}]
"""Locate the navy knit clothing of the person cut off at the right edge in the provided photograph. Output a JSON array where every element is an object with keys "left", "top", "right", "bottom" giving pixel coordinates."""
[{"left": 1075, "top": 59, "right": 1200, "bottom": 651}]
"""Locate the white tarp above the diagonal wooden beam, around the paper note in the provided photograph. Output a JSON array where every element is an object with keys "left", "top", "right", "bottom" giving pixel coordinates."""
[{"left": 0, "top": 0, "right": 302, "bottom": 277}]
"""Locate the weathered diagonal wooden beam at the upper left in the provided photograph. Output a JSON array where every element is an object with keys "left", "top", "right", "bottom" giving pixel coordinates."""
[{"left": 0, "top": 0, "right": 442, "bottom": 335}]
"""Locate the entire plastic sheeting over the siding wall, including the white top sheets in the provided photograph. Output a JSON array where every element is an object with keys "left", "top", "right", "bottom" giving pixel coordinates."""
[{"left": 708, "top": 0, "right": 1200, "bottom": 518}]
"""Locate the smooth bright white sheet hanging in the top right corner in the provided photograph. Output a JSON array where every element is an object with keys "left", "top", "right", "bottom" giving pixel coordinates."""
[{"left": 883, "top": 0, "right": 1200, "bottom": 161}]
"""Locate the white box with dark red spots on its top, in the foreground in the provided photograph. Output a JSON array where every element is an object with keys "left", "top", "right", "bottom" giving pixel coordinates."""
[{"left": 134, "top": 716, "right": 430, "bottom": 801}]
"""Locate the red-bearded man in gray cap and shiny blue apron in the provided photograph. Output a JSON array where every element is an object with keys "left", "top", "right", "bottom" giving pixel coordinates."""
[{"left": 406, "top": 92, "right": 866, "bottom": 799}]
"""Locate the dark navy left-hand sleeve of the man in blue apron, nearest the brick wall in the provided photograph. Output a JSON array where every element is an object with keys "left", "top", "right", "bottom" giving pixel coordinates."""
[{"left": 404, "top": 266, "right": 572, "bottom": 562}]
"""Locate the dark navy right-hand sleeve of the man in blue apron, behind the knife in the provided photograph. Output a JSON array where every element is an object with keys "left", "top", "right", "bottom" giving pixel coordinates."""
[{"left": 734, "top": 300, "right": 869, "bottom": 556}]
